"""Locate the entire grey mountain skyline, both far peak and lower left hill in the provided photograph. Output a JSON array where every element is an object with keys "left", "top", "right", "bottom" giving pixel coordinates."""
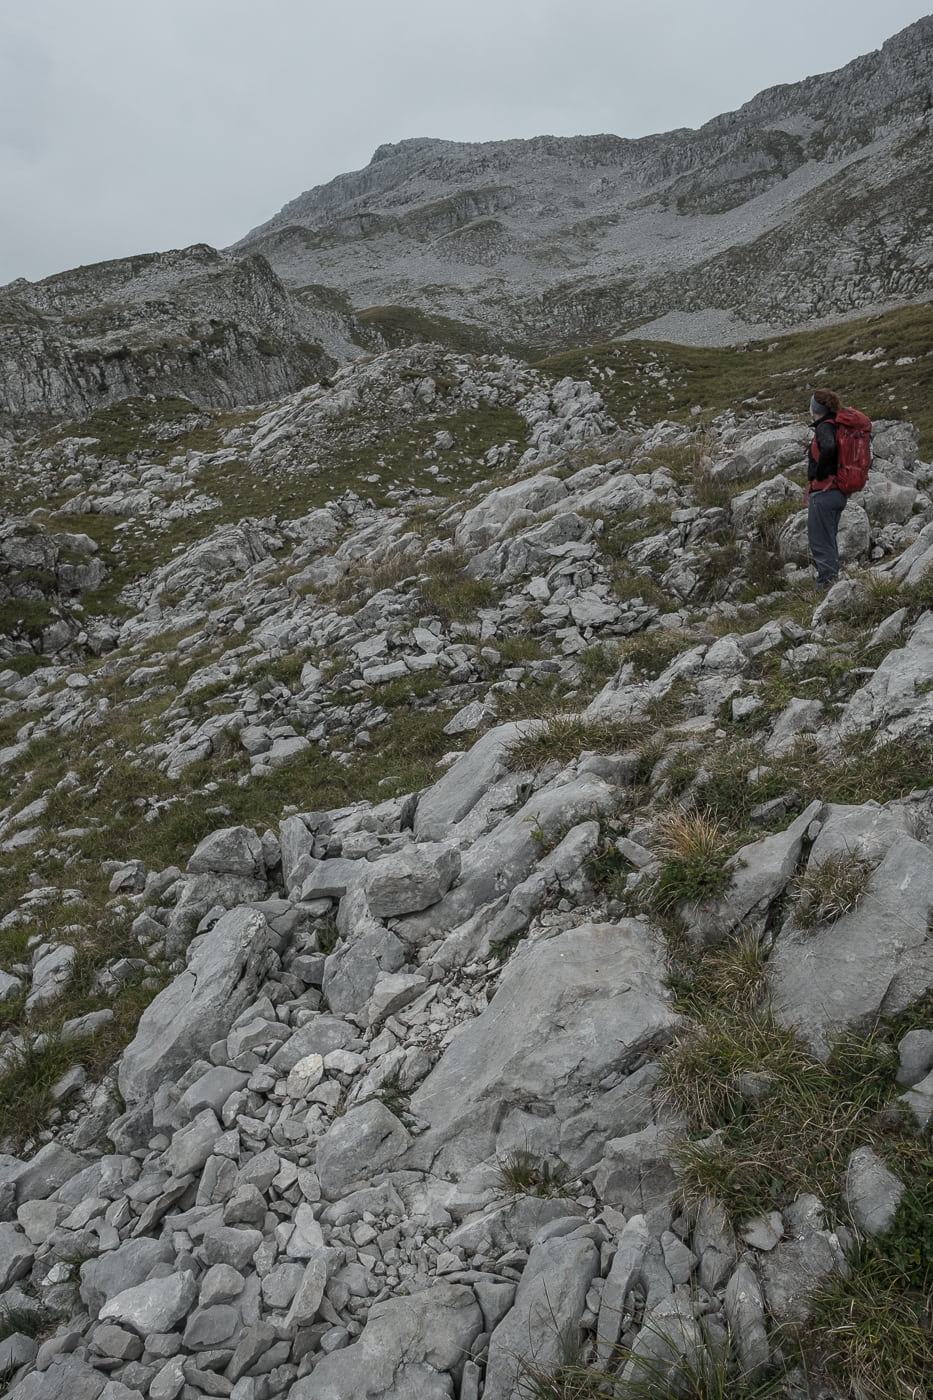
[{"left": 0, "top": 17, "right": 933, "bottom": 428}]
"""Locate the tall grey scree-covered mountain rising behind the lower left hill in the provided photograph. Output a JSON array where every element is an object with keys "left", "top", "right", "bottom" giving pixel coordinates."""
[{"left": 232, "top": 17, "right": 933, "bottom": 349}]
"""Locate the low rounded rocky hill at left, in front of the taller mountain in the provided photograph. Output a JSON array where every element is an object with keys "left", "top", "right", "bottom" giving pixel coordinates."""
[{"left": 0, "top": 245, "right": 347, "bottom": 427}]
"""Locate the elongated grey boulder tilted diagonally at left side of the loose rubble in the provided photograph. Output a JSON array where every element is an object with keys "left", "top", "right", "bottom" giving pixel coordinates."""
[{"left": 119, "top": 907, "right": 275, "bottom": 1105}]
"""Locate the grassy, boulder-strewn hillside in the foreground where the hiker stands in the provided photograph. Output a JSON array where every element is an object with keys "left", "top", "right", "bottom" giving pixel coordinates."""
[{"left": 0, "top": 338, "right": 933, "bottom": 1400}]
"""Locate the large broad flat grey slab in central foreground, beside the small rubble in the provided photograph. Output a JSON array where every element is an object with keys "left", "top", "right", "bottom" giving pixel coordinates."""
[{"left": 412, "top": 918, "right": 679, "bottom": 1175}]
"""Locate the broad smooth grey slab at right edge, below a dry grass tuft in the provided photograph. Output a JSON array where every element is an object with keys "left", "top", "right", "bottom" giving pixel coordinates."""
[{"left": 768, "top": 836, "right": 933, "bottom": 1056}]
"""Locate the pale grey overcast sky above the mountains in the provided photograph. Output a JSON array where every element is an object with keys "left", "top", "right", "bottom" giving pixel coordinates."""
[{"left": 0, "top": 0, "right": 929, "bottom": 284}]
